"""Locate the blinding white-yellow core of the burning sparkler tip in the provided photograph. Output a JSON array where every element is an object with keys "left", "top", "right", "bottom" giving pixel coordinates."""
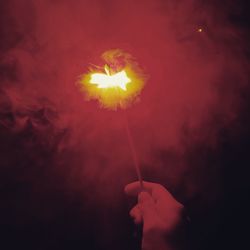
[{"left": 90, "top": 65, "right": 131, "bottom": 91}]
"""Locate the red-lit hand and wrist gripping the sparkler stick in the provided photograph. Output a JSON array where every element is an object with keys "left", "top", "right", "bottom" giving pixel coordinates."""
[{"left": 125, "top": 182, "right": 183, "bottom": 250}]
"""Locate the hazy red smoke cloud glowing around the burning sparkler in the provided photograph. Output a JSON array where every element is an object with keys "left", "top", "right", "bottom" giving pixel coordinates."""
[{"left": 0, "top": 0, "right": 248, "bottom": 249}]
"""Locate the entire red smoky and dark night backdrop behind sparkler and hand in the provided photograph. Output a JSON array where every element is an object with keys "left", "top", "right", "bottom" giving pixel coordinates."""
[{"left": 0, "top": 0, "right": 250, "bottom": 250}]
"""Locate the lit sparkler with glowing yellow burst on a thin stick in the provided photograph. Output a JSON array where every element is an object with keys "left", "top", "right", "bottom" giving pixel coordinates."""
[{"left": 80, "top": 49, "right": 146, "bottom": 188}]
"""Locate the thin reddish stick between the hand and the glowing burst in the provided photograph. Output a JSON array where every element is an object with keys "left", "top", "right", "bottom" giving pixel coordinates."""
[{"left": 124, "top": 112, "right": 143, "bottom": 189}]
